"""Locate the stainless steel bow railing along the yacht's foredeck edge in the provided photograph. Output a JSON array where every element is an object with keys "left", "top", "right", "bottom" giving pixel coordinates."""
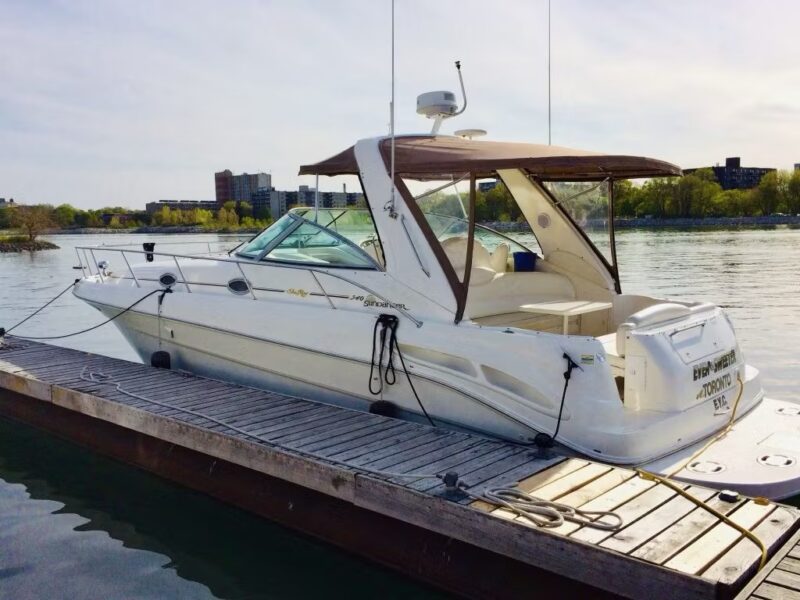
[{"left": 75, "top": 246, "right": 423, "bottom": 327}]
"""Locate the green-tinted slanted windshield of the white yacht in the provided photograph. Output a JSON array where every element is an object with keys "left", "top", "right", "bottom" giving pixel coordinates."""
[{"left": 237, "top": 210, "right": 380, "bottom": 269}]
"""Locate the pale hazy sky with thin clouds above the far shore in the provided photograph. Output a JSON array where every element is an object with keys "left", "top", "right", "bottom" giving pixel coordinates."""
[{"left": 0, "top": 0, "right": 800, "bottom": 208}]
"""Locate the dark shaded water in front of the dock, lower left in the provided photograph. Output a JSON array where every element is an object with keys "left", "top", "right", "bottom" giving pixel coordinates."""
[{"left": 0, "top": 418, "right": 439, "bottom": 600}]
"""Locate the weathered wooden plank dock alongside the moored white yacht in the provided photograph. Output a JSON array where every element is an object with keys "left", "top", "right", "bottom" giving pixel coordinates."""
[{"left": 0, "top": 337, "right": 800, "bottom": 600}]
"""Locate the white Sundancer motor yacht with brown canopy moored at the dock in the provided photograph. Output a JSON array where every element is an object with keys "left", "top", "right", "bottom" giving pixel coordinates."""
[{"left": 74, "top": 135, "right": 800, "bottom": 498}]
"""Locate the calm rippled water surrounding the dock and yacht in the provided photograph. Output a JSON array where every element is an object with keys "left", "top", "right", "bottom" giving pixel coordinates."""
[{"left": 0, "top": 228, "right": 800, "bottom": 599}]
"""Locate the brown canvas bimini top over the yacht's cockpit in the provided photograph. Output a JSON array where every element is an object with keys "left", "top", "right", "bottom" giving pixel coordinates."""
[{"left": 300, "top": 136, "right": 682, "bottom": 181}]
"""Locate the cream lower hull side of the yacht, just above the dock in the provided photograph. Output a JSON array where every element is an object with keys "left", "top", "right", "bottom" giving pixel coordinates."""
[{"left": 98, "top": 306, "right": 537, "bottom": 442}]
